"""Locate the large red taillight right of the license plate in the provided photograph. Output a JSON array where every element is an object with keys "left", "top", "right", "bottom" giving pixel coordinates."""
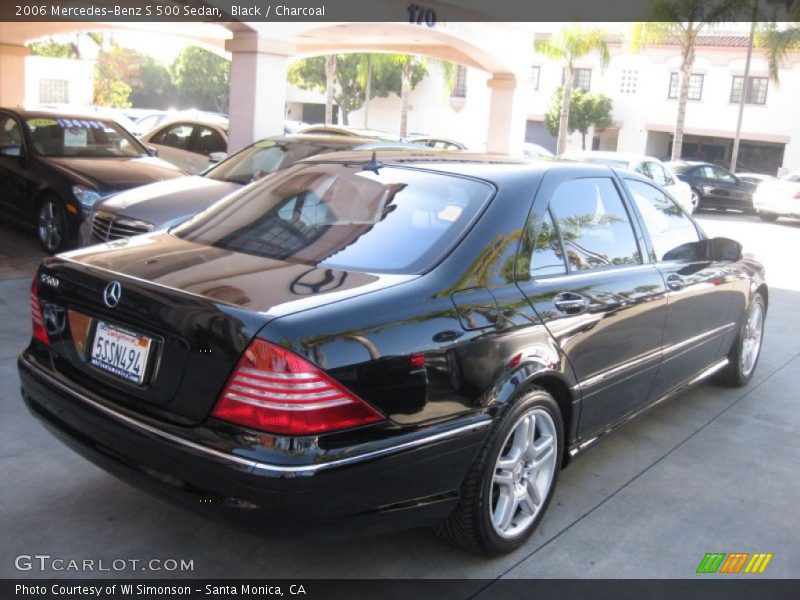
[{"left": 212, "top": 340, "right": 383, "bottom": 435}]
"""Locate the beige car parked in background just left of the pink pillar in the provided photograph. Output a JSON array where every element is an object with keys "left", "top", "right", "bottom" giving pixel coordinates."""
[{"left": 139, "top": 119, "right": 228, "bottom": 175}]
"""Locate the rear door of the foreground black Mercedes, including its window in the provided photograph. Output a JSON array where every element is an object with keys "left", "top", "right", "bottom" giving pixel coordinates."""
[{"left": 518, "top": 169, "right": 666, "bottom": 438}]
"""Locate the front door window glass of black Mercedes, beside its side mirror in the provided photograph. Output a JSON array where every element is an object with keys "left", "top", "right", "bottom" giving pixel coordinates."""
[{"left": 625, "top": 179, "right": 700, "bottom": 261}]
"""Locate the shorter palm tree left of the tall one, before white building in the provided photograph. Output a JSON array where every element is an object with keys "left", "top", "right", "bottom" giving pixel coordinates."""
[{"left": 534, "top": 27, "right": 611, "bottom": 154}]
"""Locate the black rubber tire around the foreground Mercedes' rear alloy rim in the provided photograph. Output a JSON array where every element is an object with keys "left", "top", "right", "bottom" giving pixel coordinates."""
[{"left": 435, "top": 387, "right": 564, "bottom": 556}]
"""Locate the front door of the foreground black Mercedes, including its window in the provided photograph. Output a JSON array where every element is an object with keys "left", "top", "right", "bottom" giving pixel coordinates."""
[{"left": 623, "top": 178, "right": 736, "bottom": 399}]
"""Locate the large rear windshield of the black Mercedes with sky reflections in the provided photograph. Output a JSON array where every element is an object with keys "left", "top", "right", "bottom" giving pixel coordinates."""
[{"left": 172, "top": 159, "right": 493, "bottom": 274}]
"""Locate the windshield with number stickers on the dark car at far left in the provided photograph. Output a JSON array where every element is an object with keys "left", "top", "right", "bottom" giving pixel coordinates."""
[{"left": 25, "top": 116, "right": 147, "bottom": 158}]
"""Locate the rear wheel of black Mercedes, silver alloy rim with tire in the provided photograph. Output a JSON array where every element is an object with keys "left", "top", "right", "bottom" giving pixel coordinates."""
[{"left": 436, "top": 388, "right": 563, "bottom": 556}]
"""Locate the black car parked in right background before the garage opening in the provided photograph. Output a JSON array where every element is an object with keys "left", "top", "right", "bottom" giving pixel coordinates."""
[{"left": 666, "top": 160, "right": 757, "bottom": 213}]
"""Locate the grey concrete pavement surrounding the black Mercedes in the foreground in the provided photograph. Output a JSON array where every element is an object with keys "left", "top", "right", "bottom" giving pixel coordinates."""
[{"left": 0, "top": 214, "right": 800, "bottom": 580}]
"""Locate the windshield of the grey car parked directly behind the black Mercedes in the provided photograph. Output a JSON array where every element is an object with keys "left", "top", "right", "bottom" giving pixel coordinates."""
[{"left": 203, "top": 140, "right": 340, "bottom": 185}]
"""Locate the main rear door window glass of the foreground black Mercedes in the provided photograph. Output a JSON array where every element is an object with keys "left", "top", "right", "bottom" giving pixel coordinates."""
[{"left": 550, "top": 177, "right": 642, "bottom": 272}]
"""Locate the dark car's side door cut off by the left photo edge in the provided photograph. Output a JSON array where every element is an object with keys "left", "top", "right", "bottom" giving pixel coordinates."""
[{"left": 0, "top": 113, "right": 30, "bottom": 220}]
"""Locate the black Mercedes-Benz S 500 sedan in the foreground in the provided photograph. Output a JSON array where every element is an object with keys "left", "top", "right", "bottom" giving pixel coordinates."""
[{"left": 19, "top": 151, "right": 768, "bottom": 554}]
